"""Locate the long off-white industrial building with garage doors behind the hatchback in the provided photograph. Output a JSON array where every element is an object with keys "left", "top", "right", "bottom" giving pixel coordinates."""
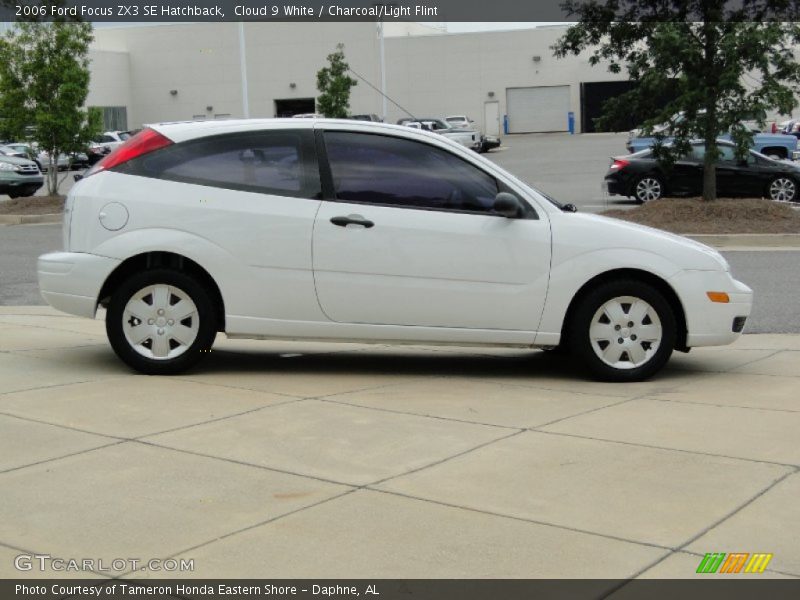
[{"left": 87, "top": 22, "right": 627, "bottom": 133}]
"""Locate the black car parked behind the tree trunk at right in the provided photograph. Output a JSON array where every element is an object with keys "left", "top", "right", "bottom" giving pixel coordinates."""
[{"left": 604, "top": 140, "right": 800, "bottom": 203}]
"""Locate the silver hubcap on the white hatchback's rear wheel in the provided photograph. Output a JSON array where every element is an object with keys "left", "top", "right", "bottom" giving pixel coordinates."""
[{"left": 122, "top": 284, "right": 200, "bottom": 360}]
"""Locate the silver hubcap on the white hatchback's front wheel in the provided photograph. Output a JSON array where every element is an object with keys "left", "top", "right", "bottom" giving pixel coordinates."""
[{"left": 589, "top": 296, "right": 663, "bottom": 369}]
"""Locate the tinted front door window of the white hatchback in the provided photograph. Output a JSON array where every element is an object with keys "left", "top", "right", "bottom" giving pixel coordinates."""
[{"left": 325, "top": 131, "right": 499, "bottom": 213}]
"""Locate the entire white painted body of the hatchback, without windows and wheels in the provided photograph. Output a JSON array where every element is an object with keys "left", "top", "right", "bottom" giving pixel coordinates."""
[{"left": 39, "top": 119, "right": 752, "bottom": 360}]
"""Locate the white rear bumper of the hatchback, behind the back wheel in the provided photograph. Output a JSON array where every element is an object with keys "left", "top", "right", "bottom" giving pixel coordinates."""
[{"left": 37, "top": 252, "right": 120, "bottom": 318}]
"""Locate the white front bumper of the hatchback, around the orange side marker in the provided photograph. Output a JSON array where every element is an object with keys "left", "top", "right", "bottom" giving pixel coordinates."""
[{"left": 670, "top": 271, "right": 753, "bottom": 348}]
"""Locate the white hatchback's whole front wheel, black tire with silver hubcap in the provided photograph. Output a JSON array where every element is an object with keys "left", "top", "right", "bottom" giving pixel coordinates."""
[{"left": 569, "top": 279, "right": 677, "bottom": 382}]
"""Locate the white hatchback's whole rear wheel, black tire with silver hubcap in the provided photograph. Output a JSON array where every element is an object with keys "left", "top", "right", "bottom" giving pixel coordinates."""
[{"left": 106, "top": 269, "right": 217, "bottom": 375}]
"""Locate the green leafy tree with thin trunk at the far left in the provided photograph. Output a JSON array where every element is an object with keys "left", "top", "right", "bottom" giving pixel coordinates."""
[{"left": 0, "top": 22, "right": 101, "bottom": 194}]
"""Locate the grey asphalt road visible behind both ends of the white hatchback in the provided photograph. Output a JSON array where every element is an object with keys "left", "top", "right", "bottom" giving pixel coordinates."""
[{"left": 0, "top": 225, "right": 800, "bottom": 333}]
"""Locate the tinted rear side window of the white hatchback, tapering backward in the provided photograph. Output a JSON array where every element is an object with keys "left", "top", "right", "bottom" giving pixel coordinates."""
[{"left": 113, "top": 130, "right": 321, "bottom": 198}]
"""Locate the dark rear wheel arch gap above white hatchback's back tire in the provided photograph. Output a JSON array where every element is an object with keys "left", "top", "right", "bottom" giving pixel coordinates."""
[{"left": 97, "top": 251, "right": 225, "bottom": 331}]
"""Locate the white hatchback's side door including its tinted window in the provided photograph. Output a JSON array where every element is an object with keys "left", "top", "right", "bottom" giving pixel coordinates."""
[{"left": 313, "top": 129, "right": 550, "bottom": 331}]
